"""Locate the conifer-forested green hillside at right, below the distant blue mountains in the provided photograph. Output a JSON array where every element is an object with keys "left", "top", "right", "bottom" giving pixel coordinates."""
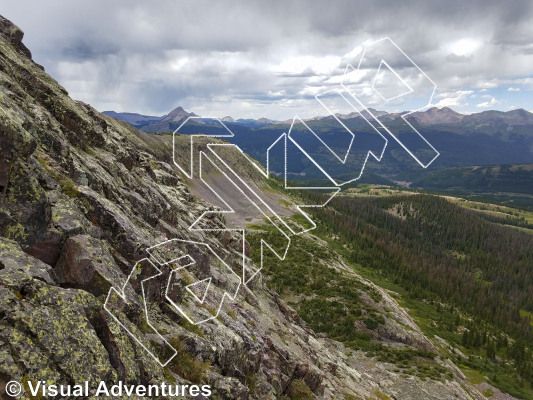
[{"left": 296, "top": 194, "right": 533, "bottom": 398}]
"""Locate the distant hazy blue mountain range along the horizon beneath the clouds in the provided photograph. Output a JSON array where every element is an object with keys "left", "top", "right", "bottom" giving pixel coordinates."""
[{"left": 105, "top": 107, "right": 533, "bottom": 193}]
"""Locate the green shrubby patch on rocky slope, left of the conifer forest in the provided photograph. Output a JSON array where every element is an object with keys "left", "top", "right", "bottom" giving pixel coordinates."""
[{"left": 248, "top": 225, "right": 452, "bottom": 380}]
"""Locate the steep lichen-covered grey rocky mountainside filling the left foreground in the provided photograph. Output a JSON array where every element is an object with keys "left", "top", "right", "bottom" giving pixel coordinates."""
[{"left": 0, "top": 18, "right": 494, "bottom": 399}]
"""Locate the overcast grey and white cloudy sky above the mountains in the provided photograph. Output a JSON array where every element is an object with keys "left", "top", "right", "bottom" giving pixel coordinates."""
[{"left": 0, "top": 0, "right": 533, "bottom": 119}]
